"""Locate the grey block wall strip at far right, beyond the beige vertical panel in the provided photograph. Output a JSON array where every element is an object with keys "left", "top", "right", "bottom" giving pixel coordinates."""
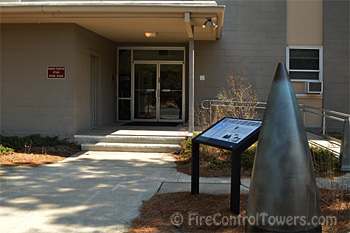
[{"left": 323, "top": 0, "right": 350, "bottom": 129}]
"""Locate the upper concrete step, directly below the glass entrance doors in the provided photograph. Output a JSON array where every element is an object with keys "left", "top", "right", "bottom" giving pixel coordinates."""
[{"left": 74, "top": 135, "right": 186, "bottom": 144}]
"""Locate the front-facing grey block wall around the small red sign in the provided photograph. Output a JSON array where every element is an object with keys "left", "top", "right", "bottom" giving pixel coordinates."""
[{"left": 1, "top": 24, "right": 74, "bottom": 137}]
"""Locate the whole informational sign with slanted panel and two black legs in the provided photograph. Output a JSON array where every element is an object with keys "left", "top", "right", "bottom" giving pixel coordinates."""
[{"left": 191, "top": 117, "right": 262, "bottom": 214}]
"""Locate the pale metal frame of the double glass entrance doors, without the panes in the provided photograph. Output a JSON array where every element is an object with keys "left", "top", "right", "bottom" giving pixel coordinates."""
[{"left": 131, "top": 60, "right": 186, "bottom": 122}]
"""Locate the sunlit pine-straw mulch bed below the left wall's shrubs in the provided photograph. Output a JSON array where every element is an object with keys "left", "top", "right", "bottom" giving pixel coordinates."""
[{"left": 0, "top": 145, "right": 80, "bottom": 167}]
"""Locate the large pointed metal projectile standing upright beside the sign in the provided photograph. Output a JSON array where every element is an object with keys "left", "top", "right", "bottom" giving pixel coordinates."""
[{"left": 246, "top": 63, "right": 322, "bottom": 232}]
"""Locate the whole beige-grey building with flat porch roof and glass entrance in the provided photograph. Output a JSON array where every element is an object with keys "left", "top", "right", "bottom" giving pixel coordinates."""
[{"left": 0, "top": 0, "right": 350, "bottom": 137}]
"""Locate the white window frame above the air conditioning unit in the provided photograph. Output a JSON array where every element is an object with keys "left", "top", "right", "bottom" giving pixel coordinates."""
[{"left": 286, "top": 45, "right": 323, "bottom": 82}]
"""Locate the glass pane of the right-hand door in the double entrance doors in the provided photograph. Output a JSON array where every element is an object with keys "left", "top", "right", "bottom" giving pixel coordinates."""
[{"left": 160, "top": 64, "right": 182, "bottom": 120}]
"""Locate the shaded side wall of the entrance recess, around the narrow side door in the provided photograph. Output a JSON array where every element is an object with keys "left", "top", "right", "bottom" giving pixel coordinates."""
[{"left": 74, "top": 25, "right": 116, "bottom": 132}]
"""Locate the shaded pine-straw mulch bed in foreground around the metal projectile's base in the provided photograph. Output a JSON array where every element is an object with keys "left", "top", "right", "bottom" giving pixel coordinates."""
[{"left": 129, "top": 189, "right": 350, "bottom": 233}]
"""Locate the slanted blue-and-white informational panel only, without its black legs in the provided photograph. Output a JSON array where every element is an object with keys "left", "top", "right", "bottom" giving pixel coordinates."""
[{"left": 195, "top": 117, "right": 262, "bottom": 149}]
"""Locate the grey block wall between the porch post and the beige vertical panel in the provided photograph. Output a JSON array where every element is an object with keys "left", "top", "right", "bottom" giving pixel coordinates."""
[{"left": 195, "top": 0, "right": 286, "bottom": 105}]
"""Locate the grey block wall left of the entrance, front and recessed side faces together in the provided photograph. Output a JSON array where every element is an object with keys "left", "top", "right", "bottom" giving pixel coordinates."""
[{"left": 0, "top": 24, "right": 115, "bottom": 138}]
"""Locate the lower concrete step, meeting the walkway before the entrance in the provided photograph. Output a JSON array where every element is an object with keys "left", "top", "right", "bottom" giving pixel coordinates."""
[{"left": 81, "top": 142, "right": 181, "bottom": 153}]
